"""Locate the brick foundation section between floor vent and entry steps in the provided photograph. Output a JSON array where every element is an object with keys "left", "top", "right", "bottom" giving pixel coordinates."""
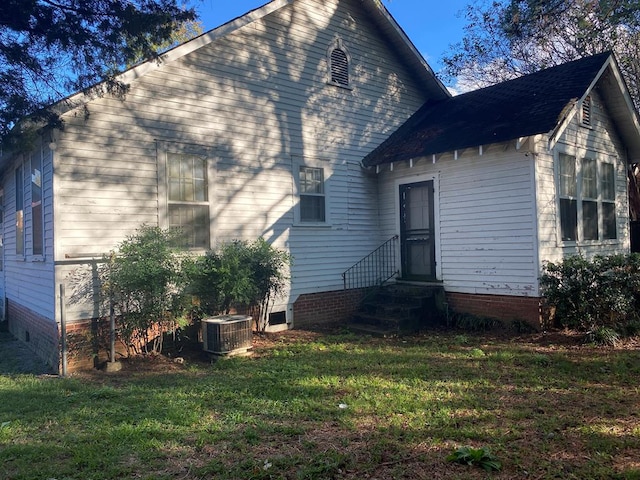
[{"left": 293, "top": 289, "right": 366, "bottom": 328}]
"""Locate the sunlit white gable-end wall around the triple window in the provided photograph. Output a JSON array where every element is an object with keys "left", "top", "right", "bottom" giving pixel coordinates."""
[{"left": 536, "top": 91, "right": 630, "bottom": 264}]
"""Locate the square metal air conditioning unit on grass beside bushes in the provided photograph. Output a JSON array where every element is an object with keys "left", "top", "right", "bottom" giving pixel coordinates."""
[{"left": 202, "top": 315, "right": 253, "bottom": 355}]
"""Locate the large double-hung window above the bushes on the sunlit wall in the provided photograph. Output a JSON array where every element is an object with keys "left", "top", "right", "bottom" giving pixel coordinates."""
[{"left": 167, "top": 153, "right": 209, "bottom": 249}]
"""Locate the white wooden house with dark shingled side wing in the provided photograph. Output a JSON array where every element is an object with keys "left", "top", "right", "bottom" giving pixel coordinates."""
[{"left": 0, "top": 0, "right": 640, "bottom": 367}]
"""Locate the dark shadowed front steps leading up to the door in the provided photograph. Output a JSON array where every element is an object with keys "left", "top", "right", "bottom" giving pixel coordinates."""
[{"left": 348, "top": 281, "right": 445, "bottom": 336}]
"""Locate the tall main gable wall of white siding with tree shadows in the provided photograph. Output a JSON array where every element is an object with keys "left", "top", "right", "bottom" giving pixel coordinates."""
[{"left": 55, "top": 0, "right": 438, "bottom": 321}]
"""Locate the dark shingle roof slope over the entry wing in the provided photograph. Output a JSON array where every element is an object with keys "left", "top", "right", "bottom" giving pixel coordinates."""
[{"left": 363, "top": 52, "right": 611, "bottom": 166}]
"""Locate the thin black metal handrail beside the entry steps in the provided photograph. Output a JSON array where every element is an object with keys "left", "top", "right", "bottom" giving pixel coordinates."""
[{"left": 342, "top": 235, "right": 399, "bottom": 290}]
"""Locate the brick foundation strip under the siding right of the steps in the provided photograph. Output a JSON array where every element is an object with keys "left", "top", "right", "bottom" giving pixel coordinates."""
[{"left": 446, "top": 292, "right": 541, "bottom": 329}]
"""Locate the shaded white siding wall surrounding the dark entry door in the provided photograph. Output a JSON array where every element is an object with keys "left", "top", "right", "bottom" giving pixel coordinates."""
[{"left": 380, "top": 146, "right": 538, "bottom": 296}]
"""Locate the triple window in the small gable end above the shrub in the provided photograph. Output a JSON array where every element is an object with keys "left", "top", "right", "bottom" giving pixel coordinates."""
[{"left": 558, "top": 153, "right": 617, "bottom": 241}]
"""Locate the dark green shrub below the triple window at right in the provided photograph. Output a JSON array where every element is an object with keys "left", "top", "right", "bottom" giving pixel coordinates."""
[{"left": 540, "top": 254, "right": 640, "bottom": 333}]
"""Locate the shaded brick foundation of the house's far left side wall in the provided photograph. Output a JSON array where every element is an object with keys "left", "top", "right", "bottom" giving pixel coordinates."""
[{"left": 7, "top": 300, "right": 60, "bottom": 372}]
